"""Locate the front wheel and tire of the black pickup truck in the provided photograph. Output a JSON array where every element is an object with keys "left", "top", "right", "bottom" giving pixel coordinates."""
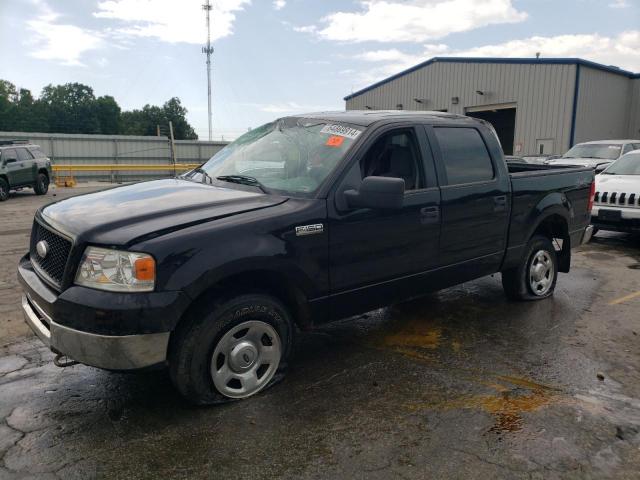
[{"left": 169, "top": 294, "right": 293, "bottom": 405}]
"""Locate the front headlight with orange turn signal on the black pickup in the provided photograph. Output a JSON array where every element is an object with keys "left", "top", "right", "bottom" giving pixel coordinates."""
[{"left": 76, "top": 247, "right": 156, "bottom": 292}]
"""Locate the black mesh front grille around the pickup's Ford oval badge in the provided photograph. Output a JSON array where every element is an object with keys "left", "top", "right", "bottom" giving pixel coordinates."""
[{"left": 30, "top": 221, "right": 72, "bottom": 288}]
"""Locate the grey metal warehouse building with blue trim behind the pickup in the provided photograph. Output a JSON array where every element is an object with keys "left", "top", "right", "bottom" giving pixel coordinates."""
[{"left": 345, "top": 58, "right": 640, "bottom": 154}]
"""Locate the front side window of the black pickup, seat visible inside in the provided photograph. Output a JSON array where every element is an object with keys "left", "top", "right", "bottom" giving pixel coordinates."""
[{"left": 360, "top": 129, "right": 425, "bottom": 191}]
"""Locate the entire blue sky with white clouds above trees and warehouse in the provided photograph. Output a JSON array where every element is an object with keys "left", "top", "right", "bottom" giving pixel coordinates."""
[{"left": 0, "top": 0, "right": 640, "bottom": 138}]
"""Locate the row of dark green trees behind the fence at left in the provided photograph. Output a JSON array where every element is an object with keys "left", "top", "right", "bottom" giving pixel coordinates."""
[{"left": 0, "top": 79, "right": 198, "bottom": 140}]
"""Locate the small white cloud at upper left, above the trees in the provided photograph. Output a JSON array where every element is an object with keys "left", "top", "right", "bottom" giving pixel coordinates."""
[{"left": 26, "top": 1, "right": 104, "bottom": 66}]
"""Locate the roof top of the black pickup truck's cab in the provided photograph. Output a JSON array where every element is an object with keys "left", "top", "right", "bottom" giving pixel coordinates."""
[{"left": 295, "top": 110, "right": 472, "bottom": 127}]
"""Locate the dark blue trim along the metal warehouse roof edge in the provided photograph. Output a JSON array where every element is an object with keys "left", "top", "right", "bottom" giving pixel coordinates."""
[{"left": 344, "top": 57, "right": 640, "bottom": 101}]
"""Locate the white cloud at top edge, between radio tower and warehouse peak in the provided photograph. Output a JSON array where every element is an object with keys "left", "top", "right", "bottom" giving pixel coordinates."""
[{"left": 296, "top": 0, "right": 527, "bottom": 42}]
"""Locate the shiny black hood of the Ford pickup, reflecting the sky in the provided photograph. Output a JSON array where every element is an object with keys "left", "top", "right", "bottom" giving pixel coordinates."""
[{"left": 39, "top": 179, "right": 287, "bottom": 245}]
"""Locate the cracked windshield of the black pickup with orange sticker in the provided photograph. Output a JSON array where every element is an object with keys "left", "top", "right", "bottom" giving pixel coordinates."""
[{"left": 183, "top": 117, "right": 362, "bottom": 194}]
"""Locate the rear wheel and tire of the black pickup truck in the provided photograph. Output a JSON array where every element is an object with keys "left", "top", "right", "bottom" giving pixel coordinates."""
[{"left": 502, "top": 235, "right": 558, "bottom": 300}]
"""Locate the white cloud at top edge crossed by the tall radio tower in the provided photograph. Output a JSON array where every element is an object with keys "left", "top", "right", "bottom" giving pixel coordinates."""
[{"left": 93, "top": 0, "right": 251, "bottom": 44}]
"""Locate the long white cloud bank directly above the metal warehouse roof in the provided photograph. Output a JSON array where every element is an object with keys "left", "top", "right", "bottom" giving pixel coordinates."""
[{"left": 355, "top": 30, "right": 640, "bottom": 85}]
